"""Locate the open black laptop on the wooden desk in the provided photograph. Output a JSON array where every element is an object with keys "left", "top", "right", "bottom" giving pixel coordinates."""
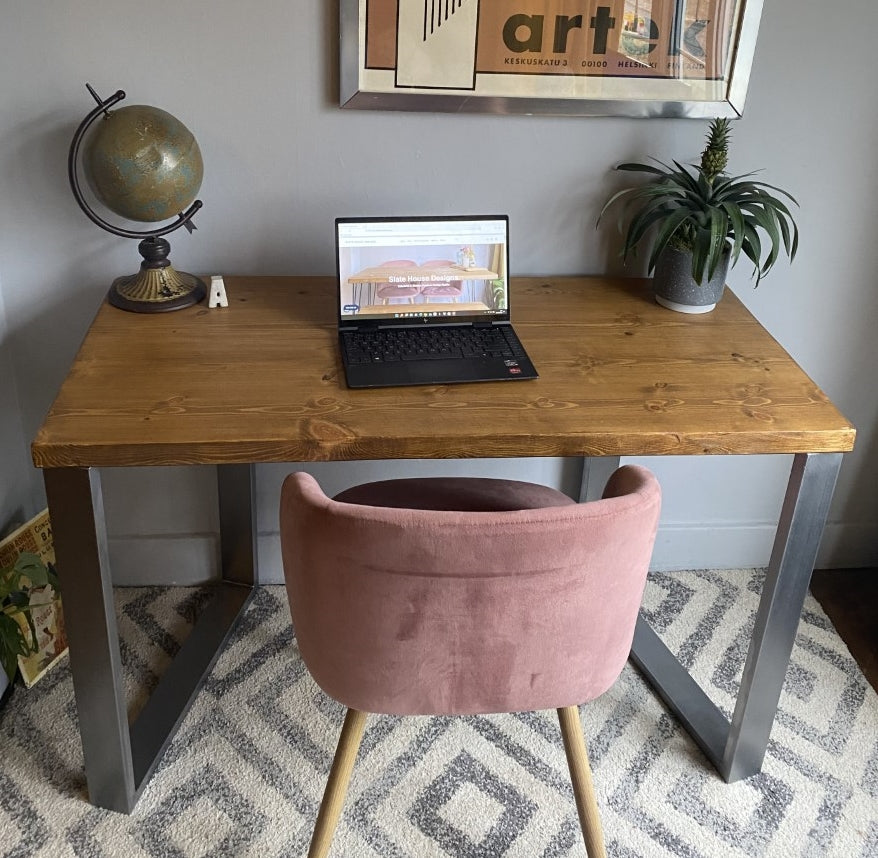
[{"left": 335, "top": 215, "right": 538, "bottom": 388}]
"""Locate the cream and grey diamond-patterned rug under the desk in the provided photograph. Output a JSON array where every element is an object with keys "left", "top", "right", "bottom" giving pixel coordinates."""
[{"left": 0, "top": 570, "right": 878, "bottom": 858}]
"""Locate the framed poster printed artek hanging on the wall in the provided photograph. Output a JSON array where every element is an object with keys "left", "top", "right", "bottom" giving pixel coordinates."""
[{"left": 340, "top": 0, "right": 762, "bottom": 118}]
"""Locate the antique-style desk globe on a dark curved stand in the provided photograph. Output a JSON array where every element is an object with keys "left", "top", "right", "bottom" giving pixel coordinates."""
[{"left": 67, "top": 84, "right": 207, "bottom": 313}]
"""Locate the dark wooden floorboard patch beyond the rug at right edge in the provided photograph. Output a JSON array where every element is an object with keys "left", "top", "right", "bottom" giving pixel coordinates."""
[{"left": 811, "top": 569, "right": 878, "bottom": 691}]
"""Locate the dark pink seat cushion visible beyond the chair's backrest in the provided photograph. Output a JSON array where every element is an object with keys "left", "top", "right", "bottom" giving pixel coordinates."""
[{"left": 334, "top": 477, "right": 576, "bottom": 512}]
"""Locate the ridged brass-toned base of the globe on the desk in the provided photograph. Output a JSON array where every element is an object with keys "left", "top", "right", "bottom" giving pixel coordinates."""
[{"left": 107, "top": 237, "right": 207, "bottom": 313}]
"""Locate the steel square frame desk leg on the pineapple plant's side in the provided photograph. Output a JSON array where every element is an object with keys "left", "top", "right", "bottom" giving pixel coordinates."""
[{"left": 631, "top": 453, "right": 842, "bottom": 783}]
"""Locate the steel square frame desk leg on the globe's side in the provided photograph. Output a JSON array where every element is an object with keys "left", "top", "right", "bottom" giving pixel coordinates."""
[{"left": 43, "top": 465, "right": 256, "bottom": 813}]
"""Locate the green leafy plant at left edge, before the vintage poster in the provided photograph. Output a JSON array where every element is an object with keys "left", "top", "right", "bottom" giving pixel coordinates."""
[{"left": 0, "top": 552, "right": 59, "bottom": 693}]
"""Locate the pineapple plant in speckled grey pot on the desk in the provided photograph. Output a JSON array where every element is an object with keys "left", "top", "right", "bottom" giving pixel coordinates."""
[{"left": 598, "top": 119, "right": 799, "bottom": 313}]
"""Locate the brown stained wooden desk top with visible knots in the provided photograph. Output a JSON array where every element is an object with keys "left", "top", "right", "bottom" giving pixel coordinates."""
[{"left": 32, "top": 277, "right": 855, "bottom": 468}]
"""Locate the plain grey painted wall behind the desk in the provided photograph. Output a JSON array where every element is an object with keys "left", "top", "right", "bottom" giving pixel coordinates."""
[{"left": 0, "top": 0, "right": 878, "bottom": 581}]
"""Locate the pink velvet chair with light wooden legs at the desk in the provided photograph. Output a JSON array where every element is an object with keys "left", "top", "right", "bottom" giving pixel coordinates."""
[{"left": 280, "top": 465, "right": 661, "bottom": 858}]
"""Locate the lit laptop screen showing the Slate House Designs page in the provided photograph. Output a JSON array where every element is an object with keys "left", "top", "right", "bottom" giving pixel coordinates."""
[{"left": 335, "top": 215, "right": 509, "bottom": 325}]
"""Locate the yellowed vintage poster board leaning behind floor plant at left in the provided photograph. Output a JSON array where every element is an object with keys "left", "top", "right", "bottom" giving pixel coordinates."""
[{"left": 0, "top": 510, "right": 67, "bottom": 688}]
